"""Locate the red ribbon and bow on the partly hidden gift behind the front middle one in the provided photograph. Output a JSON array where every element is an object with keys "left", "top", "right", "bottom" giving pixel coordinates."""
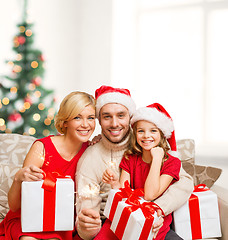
[{"left": 109, "top": 181, "right": 144, "bottom": 221}]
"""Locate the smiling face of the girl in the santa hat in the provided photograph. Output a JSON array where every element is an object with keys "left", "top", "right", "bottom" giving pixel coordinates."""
[{"left": 136, "top": 120, "right": 161, "bottom": 151}]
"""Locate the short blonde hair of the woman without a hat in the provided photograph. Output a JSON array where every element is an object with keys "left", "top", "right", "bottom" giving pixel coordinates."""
[{"left": 55, "top": 91, "right": 95, "bottom": 134}]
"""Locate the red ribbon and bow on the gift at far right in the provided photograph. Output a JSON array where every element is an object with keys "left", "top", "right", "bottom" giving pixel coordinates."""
[{"left": 189, "top": 184, "right": 209, "bottom": 239}]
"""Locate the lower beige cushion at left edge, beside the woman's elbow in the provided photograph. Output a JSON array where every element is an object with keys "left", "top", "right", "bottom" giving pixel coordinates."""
[{"left": 0, "top": 163, "right": 21, "bottom": 220}]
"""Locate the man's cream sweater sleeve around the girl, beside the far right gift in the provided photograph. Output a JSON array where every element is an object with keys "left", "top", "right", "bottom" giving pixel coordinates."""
[{"left": 154, "top": 167, "right": 194, "bottom": 215}]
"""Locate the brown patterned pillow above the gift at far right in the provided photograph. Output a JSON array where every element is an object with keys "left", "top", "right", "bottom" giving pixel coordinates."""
[{"left": 195, "top": 165, "right": 222, "bottom": 188}]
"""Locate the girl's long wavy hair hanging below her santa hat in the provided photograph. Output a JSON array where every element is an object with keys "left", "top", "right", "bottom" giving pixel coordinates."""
[{"left": 124, "top": 122, "right": 170, "bottom": 164}]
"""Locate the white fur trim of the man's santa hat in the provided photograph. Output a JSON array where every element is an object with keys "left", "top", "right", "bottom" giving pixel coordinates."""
[{"left": 96, "top": 92, "right": 136, "bottom": 116}]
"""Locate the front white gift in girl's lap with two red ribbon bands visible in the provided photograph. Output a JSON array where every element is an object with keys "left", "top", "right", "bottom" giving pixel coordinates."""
[{"left": 111, "top": 197, "right": 159, "bottom": 240}]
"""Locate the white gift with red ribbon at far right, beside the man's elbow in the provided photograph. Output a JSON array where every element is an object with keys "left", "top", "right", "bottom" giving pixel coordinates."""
[{"left": 173, "top": 184, "right": 221, "bottom": 240}]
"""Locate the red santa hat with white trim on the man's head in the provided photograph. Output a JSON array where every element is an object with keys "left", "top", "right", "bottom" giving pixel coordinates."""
[{"left": 95, "top": 85, "right": 136, "bottom": 116}]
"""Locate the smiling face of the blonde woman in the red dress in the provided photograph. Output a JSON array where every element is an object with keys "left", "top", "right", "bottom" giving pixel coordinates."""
[{"left": 64, "top": 105, "right": 96, "bottom": 142}]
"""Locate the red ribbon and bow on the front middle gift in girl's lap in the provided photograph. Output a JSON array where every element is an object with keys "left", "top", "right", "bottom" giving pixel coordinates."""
[{"left": 115, "top": 183, "right": 162, "bottom": 240}]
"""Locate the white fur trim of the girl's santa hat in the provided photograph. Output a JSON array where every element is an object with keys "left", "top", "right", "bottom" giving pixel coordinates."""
[{"left": 131, "top": 107, "right": 174, "bottom": 139}]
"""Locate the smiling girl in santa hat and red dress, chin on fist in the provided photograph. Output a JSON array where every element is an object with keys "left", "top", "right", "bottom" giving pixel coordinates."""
[{"left": 103, "top": 103, "right": 181, "bottom": 239}]
